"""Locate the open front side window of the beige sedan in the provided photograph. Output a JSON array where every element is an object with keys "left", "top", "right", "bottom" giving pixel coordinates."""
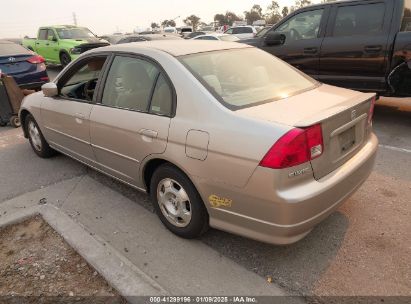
[{"left": 58, "top": 56, "right": 106, "bottom": 101}]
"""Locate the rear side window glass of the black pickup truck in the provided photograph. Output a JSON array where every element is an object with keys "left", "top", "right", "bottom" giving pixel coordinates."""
[{"left": 333, "top": 3, "right": 385, "bottom": 37}]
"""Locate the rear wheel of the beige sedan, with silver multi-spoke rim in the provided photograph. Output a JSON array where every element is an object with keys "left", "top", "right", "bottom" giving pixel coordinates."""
[{"left": 150, "top": 164, "right": 209, "bottom": 239}]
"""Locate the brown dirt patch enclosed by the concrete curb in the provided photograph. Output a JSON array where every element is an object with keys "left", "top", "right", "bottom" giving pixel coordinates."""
[{"left": 0, "top": 217, "right": 126, "bottom": 303}]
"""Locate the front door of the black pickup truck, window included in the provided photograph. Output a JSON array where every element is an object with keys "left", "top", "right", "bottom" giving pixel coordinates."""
[{"left": 261, "top": 6, "right": 329, "bottom": 78}]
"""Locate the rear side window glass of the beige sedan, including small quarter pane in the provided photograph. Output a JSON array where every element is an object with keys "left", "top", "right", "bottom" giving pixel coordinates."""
[{"left": 101, "top": 56, "right": 172, "bottom": 115}]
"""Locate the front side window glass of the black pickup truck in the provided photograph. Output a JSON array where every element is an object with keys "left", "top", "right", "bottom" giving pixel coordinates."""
[{"left": 275, "top": 9, "right": 324, "bottom": 44}]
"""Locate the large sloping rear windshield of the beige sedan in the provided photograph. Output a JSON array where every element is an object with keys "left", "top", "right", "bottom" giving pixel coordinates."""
[{"left": 180, "top": 48, "right": 318, "bottom": 110}]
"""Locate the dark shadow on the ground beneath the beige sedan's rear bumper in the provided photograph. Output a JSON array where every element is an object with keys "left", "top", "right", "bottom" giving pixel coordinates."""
[{"left": 201, "top": 212, "right": 348, "bottom": 296}]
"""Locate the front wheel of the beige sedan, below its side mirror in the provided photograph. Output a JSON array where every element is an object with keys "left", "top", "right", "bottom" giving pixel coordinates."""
[{"left": 24, "top": 114, "right": 56, "bottom": 158}]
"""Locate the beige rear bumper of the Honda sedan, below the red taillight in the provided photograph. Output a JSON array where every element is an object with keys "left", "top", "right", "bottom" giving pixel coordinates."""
[{"left": 200, "top": 134, "right": 378, "bottom": 244}]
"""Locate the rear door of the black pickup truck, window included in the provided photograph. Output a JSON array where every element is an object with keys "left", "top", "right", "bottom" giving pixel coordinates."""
[{"left": 319, "top": 0, "right": 393, "bottom": 91}]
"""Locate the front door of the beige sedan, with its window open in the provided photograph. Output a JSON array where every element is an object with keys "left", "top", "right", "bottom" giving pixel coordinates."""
[{"left": 41, "top": 55, "right": 107, "bottom": 165}]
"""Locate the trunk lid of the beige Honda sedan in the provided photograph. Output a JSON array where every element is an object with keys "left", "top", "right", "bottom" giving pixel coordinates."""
[{"left": 237, "top": 85, "right": 375, "bottom": 180}]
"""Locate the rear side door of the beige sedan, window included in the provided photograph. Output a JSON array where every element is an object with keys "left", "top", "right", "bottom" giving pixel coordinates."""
[{"left": 90, "top": 55, "right": 175, "bottom": 185}]
